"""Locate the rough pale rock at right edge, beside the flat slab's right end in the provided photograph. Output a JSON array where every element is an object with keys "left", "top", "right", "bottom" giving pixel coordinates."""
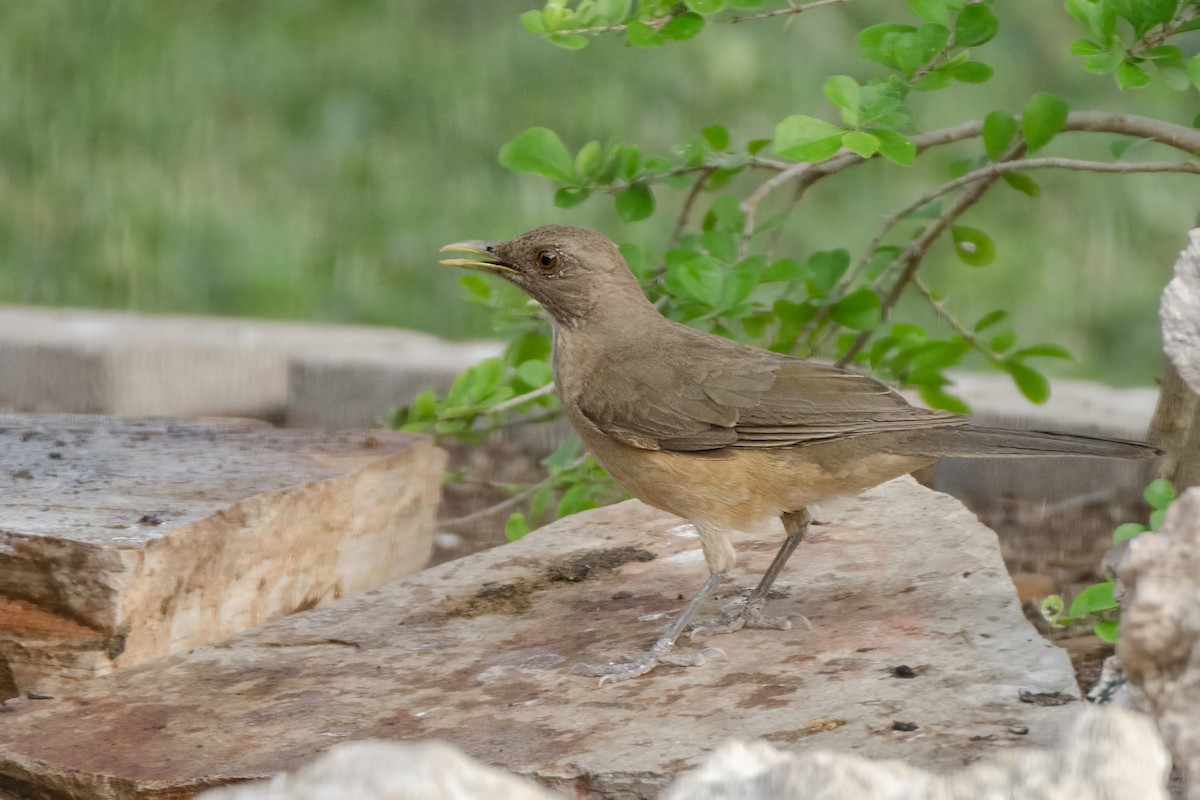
[{"left": 1117, "top": 487, "right": 1200, "bottom": 800}]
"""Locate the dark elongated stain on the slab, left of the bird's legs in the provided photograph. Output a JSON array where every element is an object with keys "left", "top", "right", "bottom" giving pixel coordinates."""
[{"left": 442, "top": 547, "right": 654, "bottom": 618}]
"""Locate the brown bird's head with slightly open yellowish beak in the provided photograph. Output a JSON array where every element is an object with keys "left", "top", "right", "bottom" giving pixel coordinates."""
[{"left": 442, "top": 225, "right": 649, "bottom": 326}]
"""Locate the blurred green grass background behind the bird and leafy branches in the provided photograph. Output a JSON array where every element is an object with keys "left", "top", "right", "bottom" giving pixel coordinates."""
[{"left": 0, "top": 0, "right": 1200, "bottom": 384}]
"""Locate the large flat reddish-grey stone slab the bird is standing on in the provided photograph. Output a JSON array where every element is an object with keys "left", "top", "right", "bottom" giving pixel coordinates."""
[{"left": 0, "top": 479, "right": 1078, "bottom": 800}]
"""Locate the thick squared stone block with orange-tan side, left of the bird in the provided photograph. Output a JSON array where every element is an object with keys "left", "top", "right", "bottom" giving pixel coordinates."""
[{"left": 0, "top": 415, "right": 443, "bottom": 698}]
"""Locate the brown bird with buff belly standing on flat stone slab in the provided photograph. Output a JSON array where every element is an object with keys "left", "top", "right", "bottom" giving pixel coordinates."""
[{"left": 442, "top": 225, "right": 1157, "bottom": 682}]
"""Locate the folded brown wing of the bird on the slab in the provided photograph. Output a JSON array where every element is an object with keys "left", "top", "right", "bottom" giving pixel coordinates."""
[{"left": 578, "top": 329, "right": 966, "bottom": 451}]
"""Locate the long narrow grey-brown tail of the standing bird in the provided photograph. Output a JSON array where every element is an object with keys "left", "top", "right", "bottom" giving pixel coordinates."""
[{"left": 921, "top": 425, "right": 1159, "bottom": 458}]
